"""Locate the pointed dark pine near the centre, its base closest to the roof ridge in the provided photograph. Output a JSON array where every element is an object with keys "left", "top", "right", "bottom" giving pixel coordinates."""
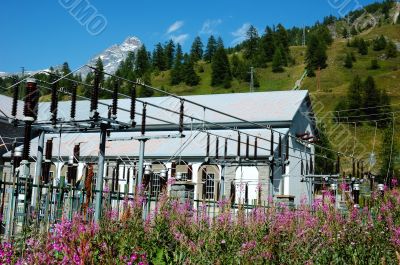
[{"left": 211, "top": 38, "right": 232, "bottom": 88}]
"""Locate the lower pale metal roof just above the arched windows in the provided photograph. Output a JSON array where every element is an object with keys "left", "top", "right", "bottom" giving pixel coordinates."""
[{"left": 4, "top": 128, "right": 289, "bottom": 158}]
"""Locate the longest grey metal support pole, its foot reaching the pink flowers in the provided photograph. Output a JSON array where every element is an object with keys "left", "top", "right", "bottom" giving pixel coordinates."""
[{"left": 94, "top": 123, "right": 107, "bottom": 223}]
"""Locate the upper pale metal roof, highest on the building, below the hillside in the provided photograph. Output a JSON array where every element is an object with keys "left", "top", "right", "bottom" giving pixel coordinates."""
[{"left": 38, "top": 90, "right": 308, "bottom": 124}]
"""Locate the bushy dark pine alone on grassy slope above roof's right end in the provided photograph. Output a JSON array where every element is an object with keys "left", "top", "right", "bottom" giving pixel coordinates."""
[{"left": 306, "top": 34, "right": 328, "bottom": 76}]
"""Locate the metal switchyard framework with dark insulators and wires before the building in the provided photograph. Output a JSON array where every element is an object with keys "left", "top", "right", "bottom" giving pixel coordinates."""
[{"left": 0, "top": 65, "right": 378, "bottom": 238}]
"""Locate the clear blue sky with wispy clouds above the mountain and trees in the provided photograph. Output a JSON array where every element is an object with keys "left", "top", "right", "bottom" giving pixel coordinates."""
[{"left": 0, "top": 0, "right": 375, "bottom": 72}]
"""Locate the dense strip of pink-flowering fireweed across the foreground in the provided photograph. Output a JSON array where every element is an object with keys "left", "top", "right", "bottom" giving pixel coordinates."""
[{"left": 0, "top": 185, "right": 400, "bottom": 264}]
